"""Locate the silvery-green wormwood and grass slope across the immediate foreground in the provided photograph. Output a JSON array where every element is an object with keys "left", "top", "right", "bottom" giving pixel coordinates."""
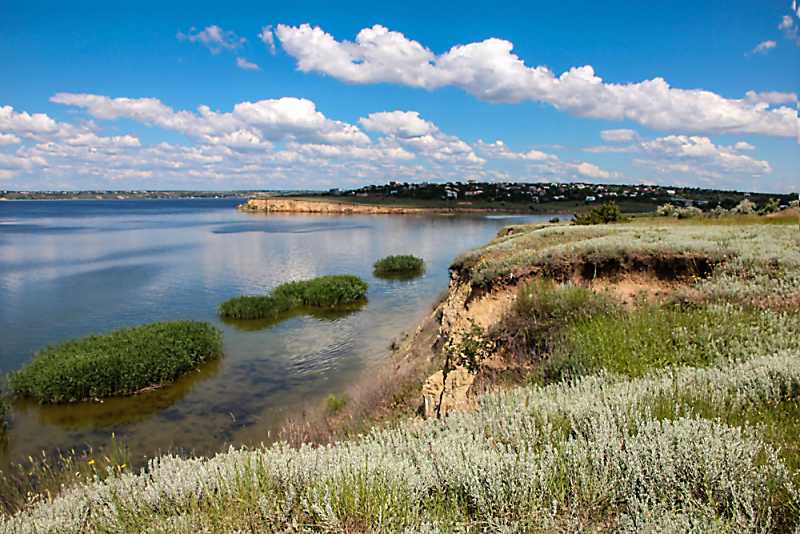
[{"left": 3, "top": 353, "right": 800, "bottom": 533}]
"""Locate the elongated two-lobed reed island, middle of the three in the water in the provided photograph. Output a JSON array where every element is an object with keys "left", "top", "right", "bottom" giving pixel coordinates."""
[{"left": 219, "top": 275, "right": 368, "bottom": 320}]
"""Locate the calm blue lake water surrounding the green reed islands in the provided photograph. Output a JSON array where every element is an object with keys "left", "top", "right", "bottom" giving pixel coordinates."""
[{"left": 0, "top": 199, "right": 560, "bottom": 464}]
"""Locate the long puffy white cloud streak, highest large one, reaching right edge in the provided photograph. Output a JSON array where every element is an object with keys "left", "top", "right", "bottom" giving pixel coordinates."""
[{"left": 275, "top": 24, "right": 798, "bottom": 137}]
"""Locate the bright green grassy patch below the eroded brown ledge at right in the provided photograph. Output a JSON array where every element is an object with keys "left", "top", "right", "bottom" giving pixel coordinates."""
[{"left": 543, "top": 304, "right": 800, "bottom": 382}]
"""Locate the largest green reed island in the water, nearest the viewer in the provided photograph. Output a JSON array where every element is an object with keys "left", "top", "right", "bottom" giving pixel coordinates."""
[{"left": 9, "top": 321, "right": 222, "bottom": 403}]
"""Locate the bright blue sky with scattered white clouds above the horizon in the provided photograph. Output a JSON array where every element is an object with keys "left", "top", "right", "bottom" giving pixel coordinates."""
[{"left": 0, "top": 0, "right": 800, "bottom": 192}]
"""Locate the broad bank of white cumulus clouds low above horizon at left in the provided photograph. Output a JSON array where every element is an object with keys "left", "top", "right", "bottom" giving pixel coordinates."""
[{"left": 0, "top": 99, "right": 494, "bottom": 188}]
